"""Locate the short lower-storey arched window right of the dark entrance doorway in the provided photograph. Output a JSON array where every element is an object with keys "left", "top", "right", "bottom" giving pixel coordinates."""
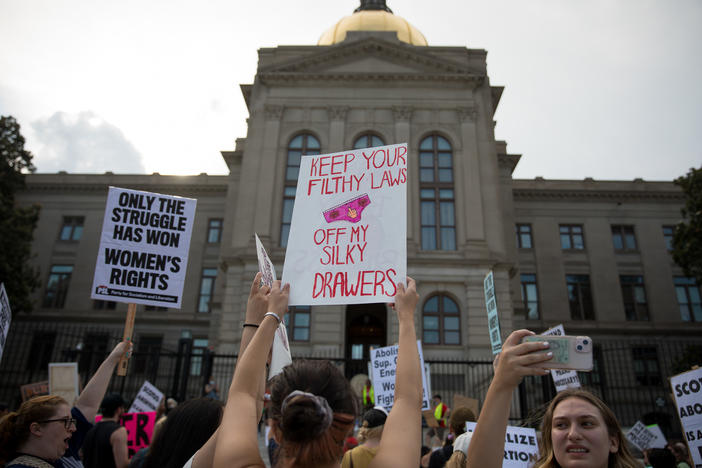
[{"left": 422, "top": 294, "right": 461, "bottom": 345}]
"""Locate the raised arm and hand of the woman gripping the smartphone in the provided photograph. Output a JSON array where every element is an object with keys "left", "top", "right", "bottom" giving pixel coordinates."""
[{"left": 467, "top": 330, "right": 552, "bottom": 468}]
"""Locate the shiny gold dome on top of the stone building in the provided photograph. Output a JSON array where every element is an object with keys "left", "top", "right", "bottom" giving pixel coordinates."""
[{"left": 317, "top": 10, "right": 428, "bottom": 46}]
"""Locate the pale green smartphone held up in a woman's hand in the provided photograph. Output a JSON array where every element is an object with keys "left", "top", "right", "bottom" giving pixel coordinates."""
[{"left": 522, "top": 335, "right": 592, "bottom": 372}]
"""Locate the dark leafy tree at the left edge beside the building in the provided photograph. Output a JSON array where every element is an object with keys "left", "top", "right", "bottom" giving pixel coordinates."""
[{"left": 0, "top": 116, "right": 39, "bottom": 315}]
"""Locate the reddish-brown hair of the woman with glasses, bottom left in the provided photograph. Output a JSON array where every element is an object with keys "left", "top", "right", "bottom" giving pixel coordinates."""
[{"left": 0, "top": 395, "right": 68, "bottom": 466}]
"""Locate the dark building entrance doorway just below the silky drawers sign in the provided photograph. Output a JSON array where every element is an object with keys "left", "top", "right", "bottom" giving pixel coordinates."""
[{"left": 346, "top": 303, "right": 387, "bottom": 379}]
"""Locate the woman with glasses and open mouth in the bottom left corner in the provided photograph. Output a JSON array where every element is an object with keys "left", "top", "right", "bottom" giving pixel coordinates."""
[{"left": 0, "top": 395, "right": 76, "bottom": 468}]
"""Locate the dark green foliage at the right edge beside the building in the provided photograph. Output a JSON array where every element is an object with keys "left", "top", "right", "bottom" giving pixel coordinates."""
[{"left": 673, "top": 168, "right": 702, "bottom": 284}]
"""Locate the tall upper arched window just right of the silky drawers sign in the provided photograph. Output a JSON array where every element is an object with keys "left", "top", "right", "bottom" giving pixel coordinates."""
[{"left": 419, "top": 135, "right": 456, "bottom": 250}]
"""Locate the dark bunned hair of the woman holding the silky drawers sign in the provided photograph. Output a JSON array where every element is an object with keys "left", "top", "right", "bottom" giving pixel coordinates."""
[{"left": 270, "top": 360, "right": 359, "bottom": 468}]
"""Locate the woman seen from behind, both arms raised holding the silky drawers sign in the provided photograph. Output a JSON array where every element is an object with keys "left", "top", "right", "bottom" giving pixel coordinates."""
[{"left": 213, "top": 278, "right": 422, "bottom": 468}]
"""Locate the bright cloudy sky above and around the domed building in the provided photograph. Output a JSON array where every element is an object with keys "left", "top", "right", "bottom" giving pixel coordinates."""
[{"left": 0, "top": 0, "right": 702, "bottom": 180}]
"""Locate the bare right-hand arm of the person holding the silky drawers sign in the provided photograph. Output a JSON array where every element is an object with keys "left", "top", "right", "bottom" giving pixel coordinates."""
[{"left": 369, "top": 277, "right": 422, "bottom": 468}]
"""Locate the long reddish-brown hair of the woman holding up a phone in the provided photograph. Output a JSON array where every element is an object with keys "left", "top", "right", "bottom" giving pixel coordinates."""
[{"left": 534, "top": 388, "right": 639, "bottom": 468}]
